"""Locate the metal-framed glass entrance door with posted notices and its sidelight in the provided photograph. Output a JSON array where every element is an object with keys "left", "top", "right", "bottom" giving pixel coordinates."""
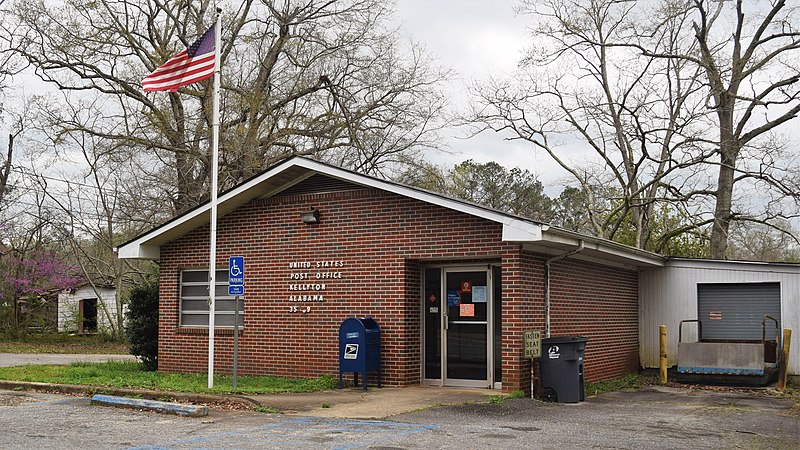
[{"left": 423, "top": 266, "right": 494, "bottom": 387}]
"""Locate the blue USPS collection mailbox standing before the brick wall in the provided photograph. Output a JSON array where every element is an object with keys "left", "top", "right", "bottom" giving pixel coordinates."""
[{"left": 339, "top": 317, "right": 381, "bottom": 391}]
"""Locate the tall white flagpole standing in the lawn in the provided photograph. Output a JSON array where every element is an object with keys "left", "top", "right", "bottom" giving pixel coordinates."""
[{"left": 208, "top": 8, "right": 222, "bottom": 389}]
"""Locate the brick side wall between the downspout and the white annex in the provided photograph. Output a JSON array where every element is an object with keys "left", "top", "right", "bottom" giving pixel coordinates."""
[{"left": 550, "top": 259, "right": 639, "bottom": 381}]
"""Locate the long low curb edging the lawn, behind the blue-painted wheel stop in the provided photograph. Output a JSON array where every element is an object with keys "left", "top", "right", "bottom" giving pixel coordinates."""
[{"left": 0, "top": 380, "right": 261, "bottom": 409}]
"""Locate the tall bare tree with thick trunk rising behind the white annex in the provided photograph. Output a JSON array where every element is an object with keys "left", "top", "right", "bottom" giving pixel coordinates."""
[{"left": 643, "top": 0, "right": 800, "bottom": 258}]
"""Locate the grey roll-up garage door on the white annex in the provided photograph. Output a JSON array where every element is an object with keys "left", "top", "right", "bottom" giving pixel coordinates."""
[{"left": 697, "top": 283, "right": 781, "bottom": 341}]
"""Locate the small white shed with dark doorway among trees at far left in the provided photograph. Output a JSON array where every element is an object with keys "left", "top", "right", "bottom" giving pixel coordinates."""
[{"left": 58, "top": 284, "right": 122, "bottom": 334}]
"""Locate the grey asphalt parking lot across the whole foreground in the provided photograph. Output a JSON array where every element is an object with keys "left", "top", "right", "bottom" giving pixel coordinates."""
[{"left": 0, "top": 387, "right": 800, "bottom": 449}]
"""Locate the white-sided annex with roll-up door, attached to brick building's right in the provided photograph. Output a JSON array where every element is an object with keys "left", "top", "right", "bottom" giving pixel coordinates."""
[{"left": 639, "top": 258, "right": 800, "bottom": 376}]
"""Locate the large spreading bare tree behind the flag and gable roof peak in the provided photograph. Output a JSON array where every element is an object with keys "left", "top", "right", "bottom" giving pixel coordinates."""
[{"left": 4, "top": 0, "right": 444, "bottom": 216}]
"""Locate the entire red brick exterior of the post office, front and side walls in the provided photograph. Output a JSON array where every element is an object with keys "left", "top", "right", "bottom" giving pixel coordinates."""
[{"left": 159, "top": 183, "right": 638, "bottom": 390}]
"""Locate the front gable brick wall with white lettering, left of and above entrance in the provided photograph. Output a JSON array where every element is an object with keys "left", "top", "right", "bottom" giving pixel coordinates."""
[{"left": 159, "top": 189, "right": 519, "bottom": 385}]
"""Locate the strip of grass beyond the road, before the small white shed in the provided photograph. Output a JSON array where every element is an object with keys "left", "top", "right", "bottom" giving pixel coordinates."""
[{"left": 0, "top": 333, "right": 128, "bottom": 355}]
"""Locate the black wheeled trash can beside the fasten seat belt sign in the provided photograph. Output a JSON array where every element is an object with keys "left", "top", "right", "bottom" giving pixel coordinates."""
[{"left": 539, "top": 336, "right": 589, "bottom": 403}]
